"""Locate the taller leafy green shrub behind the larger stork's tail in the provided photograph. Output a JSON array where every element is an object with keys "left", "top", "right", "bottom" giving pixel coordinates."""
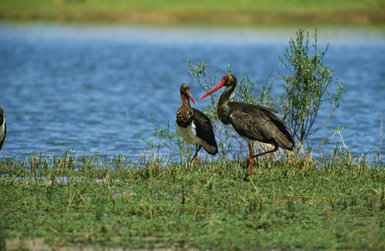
[{"left": 279, "top": 29, "right": 345, "bottom": 143}]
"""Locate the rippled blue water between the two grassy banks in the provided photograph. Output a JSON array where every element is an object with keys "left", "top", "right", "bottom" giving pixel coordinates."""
[{"left": 0, "top": 23, "right": 385, "bottom": 160}]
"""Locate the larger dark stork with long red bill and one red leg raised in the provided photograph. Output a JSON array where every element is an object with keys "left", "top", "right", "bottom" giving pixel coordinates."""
[{"left": 199, "top": 74, "right": 295, "bottom": 176}]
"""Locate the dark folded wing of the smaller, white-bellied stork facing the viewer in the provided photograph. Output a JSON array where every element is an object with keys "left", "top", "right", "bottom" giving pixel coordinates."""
[{"left": 193, "top": 108, "right": 218, "bottom": 154}]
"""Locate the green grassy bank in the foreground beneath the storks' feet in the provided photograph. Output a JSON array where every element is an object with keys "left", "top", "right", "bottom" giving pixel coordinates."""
[{"left": 0, "top": 152, "right": 385, "bottom": 250}]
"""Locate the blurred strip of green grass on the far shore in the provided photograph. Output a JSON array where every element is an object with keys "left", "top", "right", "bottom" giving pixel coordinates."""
[{"left": 0, "top": 0, "right": 385, "bottom": 26}]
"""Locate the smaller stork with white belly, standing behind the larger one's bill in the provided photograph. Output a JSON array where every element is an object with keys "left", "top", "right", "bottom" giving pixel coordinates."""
[{"left": 176, "top": 84, "right": 218, "bottom": 161}]
